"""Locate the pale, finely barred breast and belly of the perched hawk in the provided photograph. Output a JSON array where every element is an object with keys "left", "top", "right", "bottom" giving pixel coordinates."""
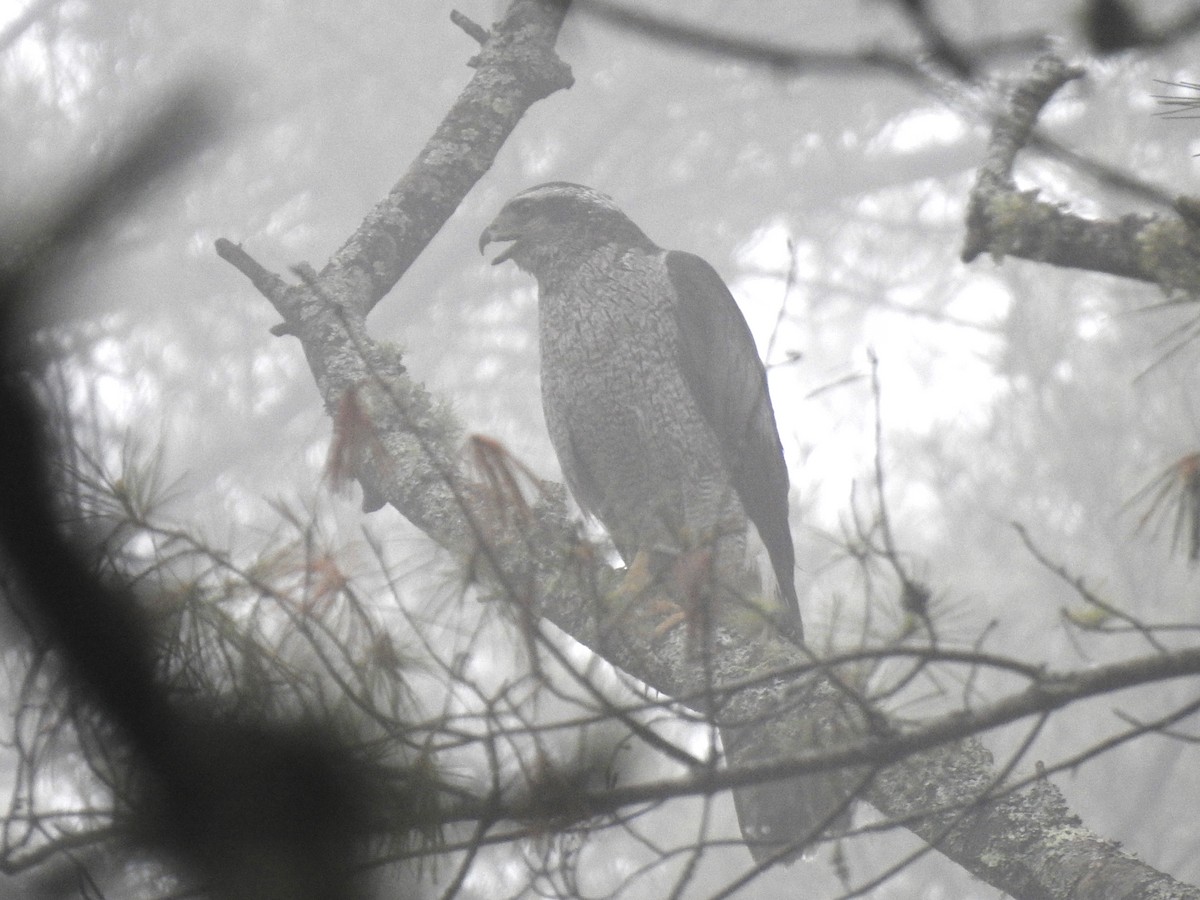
[{"left": 539, "top": 247, "right": 721, "bottom": 530}]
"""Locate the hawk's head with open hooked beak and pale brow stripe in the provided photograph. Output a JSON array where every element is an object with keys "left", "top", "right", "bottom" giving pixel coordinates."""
[{"left": 479, "top": 181, "right": 654, "bottom": 275}]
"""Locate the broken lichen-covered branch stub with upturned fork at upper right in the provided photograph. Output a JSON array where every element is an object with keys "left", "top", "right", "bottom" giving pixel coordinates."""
[{"left": 962, "top": 56, "right": 1200, "bottom": 295}]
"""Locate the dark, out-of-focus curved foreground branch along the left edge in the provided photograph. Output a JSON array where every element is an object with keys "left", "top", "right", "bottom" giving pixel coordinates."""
[{"left": 0, "top": 90, "right": 402, "bottom": 900}]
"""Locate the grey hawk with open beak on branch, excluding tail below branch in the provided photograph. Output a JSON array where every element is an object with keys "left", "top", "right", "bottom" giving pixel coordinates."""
[{"left": 480, "top": 181, "right": 802, "bottom": 641}]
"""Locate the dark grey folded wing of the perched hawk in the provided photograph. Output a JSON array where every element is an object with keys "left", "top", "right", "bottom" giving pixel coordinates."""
[{"left": 666, "top": 252, "right": 800, "bottom": 624}]
